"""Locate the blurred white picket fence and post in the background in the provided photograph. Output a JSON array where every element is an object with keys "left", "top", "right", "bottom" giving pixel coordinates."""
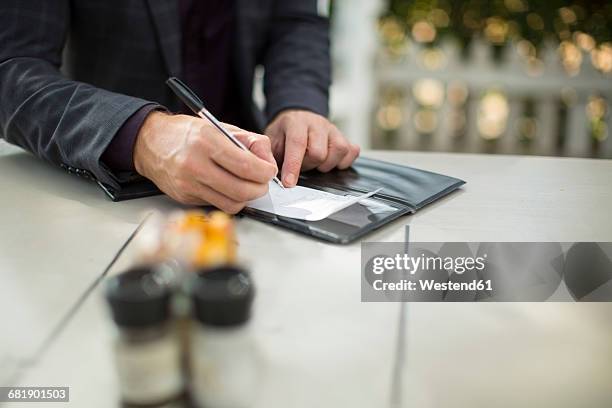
[{"left": 332, "top": 0, "right": 612, "bottom": 158}]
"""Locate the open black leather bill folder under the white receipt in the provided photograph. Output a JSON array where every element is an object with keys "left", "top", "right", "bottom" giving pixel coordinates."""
[{"left": 99, "top": 157, "right": 465, "bottom": 244}]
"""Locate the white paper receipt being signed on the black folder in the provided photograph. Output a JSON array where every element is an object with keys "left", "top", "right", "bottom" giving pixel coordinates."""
[{"left": 247, "top": 182, "right": 382, "bottom": 221}]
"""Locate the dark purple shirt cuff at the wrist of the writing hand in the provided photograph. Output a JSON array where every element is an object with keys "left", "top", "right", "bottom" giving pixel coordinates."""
[{"left": 101, "top": 103, "right": 165, "bottom": 172}]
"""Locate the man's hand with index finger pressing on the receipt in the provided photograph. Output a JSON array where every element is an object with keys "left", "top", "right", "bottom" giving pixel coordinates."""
[{"left": 265, "top": 110, "right": 359, "bottom": 187}]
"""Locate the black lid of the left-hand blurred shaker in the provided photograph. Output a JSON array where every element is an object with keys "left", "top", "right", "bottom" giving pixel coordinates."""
[{"left": 106, "top": 266, "right": 172, "bottom": 328}]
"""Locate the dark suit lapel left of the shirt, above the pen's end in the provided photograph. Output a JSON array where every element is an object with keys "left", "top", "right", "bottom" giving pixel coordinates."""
[{"left": 147, "top": 0, "right": 182, "bottom": 76}]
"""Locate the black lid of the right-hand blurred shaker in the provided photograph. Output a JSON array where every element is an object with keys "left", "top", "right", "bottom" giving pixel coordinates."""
[{"left": 188, "top": 265, "right": 255, "bottom": 326}]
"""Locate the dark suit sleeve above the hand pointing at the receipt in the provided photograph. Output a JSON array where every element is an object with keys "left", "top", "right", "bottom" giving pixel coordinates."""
[{"left": 264, "top": 0, "right": 331, "bottom": 121}]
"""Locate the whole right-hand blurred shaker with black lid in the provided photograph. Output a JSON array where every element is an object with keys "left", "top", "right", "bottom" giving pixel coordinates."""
[{"left": 188, "top": 265, "right": 258, "bottom": 408}]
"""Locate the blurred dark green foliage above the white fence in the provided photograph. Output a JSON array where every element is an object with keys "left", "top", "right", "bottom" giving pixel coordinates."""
[{"left": 385, "top": 0, "right": 612, "bottom": 46}]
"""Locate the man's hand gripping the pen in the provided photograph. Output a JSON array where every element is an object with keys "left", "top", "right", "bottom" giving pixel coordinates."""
[{"left": 134, "top": 112, "right": 278, "bottom": 214}]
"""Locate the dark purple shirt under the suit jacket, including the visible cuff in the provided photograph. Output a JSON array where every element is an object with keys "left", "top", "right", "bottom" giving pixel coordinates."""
[{"left": 102, "top": 0, "right": 238, "bottom": 171}]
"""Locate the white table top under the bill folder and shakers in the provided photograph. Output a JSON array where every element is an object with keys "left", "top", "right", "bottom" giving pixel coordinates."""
[{"left": 0, "top": 142, "right": 612, "bottom": 408}]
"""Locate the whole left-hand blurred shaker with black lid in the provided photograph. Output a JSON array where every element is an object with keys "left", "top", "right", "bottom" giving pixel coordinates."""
[{"left": 106, "top": 266, "right": 185, "bottom": 407}]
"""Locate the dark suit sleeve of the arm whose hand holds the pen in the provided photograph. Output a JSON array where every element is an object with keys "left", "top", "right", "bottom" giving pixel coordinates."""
[{"left": 0, "top": 0, "right": 158, "bottom": 187}]
